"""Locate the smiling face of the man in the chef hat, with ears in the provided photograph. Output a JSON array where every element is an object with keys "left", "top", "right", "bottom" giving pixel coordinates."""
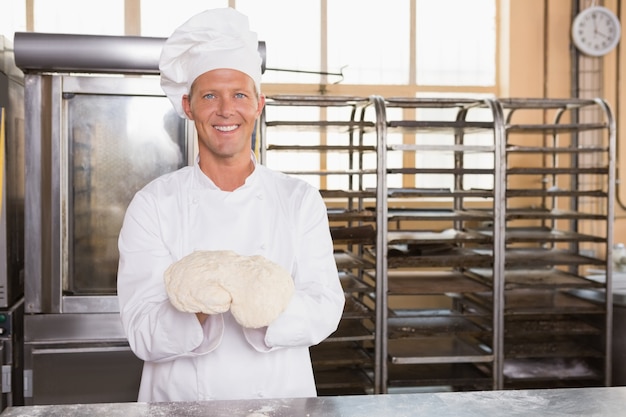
[{"left": 183, "top": 69, "right": 265, "bottom": 159}]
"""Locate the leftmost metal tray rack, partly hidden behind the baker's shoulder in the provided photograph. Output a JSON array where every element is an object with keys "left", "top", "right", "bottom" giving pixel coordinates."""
[{"left": 259, "top": 96, "right": 379, "bottom": 395}]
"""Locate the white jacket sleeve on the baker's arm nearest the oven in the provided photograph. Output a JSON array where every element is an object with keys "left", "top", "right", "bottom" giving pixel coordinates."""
[{"left": 118, "top": 172, "right": 223, "bottom": 361}]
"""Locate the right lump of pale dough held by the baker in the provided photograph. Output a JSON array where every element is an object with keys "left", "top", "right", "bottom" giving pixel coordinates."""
[{"left": 222, "top": 255, "right": 294, "bottom": 329}]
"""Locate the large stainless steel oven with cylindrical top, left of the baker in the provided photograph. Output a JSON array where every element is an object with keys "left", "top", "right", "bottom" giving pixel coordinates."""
[{"left": 15, "top": 33, "right": 193, "bottom": 404}]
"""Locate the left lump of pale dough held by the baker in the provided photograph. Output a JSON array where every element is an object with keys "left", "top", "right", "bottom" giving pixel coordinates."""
[{"left": 164, "top": 251, "right": 237, "bottom": 314}]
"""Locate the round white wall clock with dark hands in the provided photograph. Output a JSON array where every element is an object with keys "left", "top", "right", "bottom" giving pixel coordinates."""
[{"left": 572, "top": 6, "right": 621, "bottom": 56}]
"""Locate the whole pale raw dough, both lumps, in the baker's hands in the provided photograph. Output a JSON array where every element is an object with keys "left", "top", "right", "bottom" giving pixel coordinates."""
[{"left": 165, "top": 251, "right": 294, "bottom": 328}]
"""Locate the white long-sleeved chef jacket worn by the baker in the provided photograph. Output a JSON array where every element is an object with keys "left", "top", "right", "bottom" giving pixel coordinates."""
[{"left": 118, "top": 158, "right": 345, "bottom": 402}]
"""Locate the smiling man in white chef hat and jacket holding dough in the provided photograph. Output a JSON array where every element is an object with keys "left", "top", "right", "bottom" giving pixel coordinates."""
[{"left": 118, "top": 8, "right": 345, "bottom": 402}]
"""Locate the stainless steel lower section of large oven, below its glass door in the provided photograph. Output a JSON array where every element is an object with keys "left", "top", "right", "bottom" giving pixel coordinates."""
[{"left": 24, "top": 313, "right": 143, "bottom": 404}]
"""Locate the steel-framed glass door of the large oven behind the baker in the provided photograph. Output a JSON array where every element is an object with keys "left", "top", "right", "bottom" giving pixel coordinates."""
[{"left": 25, "top": 75, "right": 192, "bottom": 313}]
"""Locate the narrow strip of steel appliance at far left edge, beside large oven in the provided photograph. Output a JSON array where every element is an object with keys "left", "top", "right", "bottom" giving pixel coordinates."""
[{"left": 0, "top": 36, "right": 24, "bottom": 410}]
